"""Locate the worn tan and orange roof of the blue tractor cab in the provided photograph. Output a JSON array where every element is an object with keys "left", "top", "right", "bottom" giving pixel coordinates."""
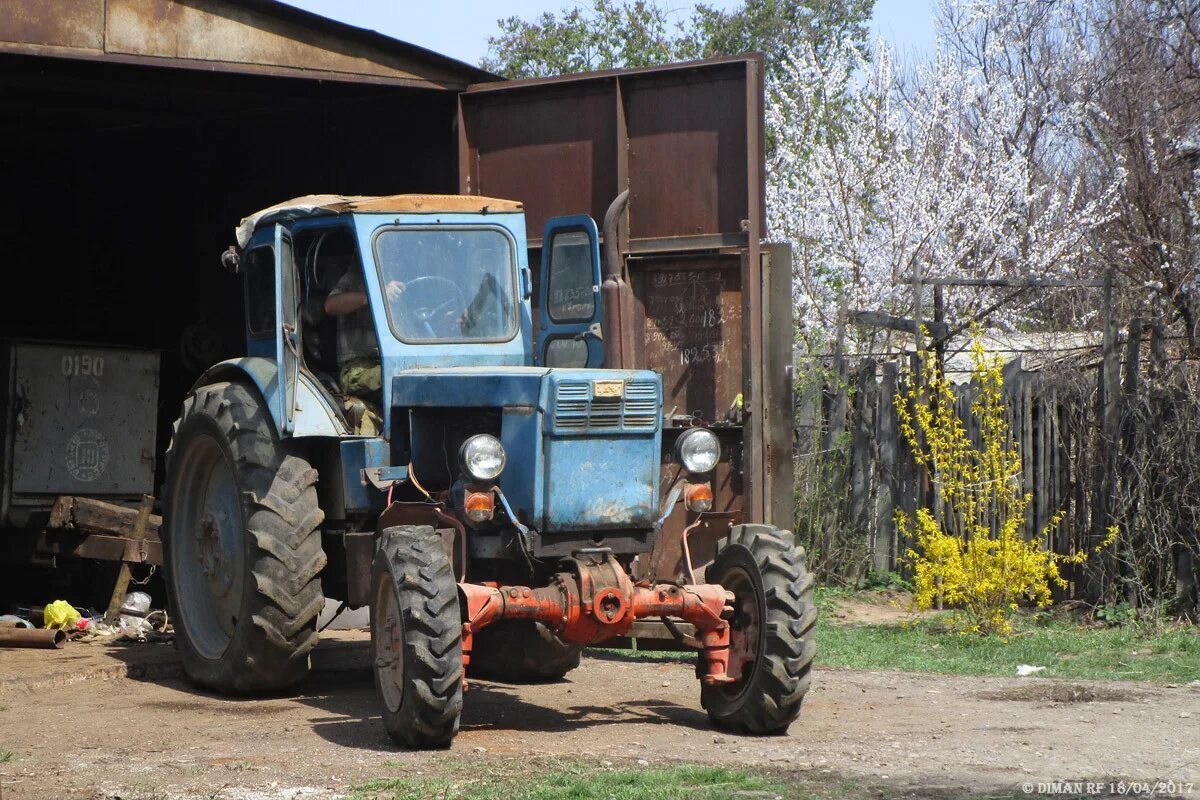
[{"left": 236, "top": 194, "right": 524, "bottom": 247}]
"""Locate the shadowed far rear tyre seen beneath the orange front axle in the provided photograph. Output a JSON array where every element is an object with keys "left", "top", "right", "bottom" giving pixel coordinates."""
[{"left": 470, "top": 619, "right": 583, "bottom": 684}]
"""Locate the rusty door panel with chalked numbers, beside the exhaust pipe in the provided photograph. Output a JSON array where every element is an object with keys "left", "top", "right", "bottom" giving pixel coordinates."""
[{"left": 631, "top": 255, "right": 743, "bottom": 422}]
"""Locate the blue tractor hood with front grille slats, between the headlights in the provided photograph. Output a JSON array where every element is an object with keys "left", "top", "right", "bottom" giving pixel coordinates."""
[{"left": 391, "top": 367, "right": 662, "bottom": 534}]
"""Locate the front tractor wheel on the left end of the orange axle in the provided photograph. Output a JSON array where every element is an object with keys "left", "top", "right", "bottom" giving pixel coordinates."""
[{"left": 371, "top": 525, "right": 462, "bottom": 748}]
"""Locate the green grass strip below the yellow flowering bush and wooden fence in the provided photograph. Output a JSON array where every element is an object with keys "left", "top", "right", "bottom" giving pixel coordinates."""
[{"left": 817, "top": 595, "right": 1200, "bottom": 682}]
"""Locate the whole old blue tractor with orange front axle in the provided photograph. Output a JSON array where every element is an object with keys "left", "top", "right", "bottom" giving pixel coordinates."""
[{"left": 163, "top": 194, "right": 816, "bottom": 747}]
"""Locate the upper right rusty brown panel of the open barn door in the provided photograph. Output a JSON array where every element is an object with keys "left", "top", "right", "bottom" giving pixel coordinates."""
[{"left": 622, "top": 64, "right": 750, "bottom": 239}]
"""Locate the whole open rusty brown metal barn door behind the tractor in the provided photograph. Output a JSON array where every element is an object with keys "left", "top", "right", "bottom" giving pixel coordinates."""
[{"left": 458, "top": 54, "right": 792, "bottom": 551}]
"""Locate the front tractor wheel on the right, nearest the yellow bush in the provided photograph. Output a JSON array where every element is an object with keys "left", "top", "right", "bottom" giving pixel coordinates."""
[{"left": 701, "top": 525, "right": 817, "bottom": 734}]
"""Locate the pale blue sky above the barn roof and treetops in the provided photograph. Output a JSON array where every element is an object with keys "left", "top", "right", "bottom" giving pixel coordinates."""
[{"left": 284, "top": 0, "right": 934, "bottom": 64}]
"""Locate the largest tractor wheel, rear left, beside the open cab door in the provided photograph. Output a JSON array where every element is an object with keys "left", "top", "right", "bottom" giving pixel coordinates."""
[{"left": 163, "top": 383, "right": 325, "bottom": 692}]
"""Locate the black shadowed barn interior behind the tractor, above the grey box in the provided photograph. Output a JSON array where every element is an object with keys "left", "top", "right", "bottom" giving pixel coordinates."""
[{"left": 0, "top": 55, "right": 456, "bottom": 470}]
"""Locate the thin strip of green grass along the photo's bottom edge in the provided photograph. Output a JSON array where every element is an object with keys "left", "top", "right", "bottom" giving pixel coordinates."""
[{"left": 349, "top": 759, "right": 825, "bottom": 800}]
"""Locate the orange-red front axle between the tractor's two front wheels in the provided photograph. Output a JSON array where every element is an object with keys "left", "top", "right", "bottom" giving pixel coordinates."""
[{"left": 458, "top": 559, "right": 740, "bottom": 685}]
